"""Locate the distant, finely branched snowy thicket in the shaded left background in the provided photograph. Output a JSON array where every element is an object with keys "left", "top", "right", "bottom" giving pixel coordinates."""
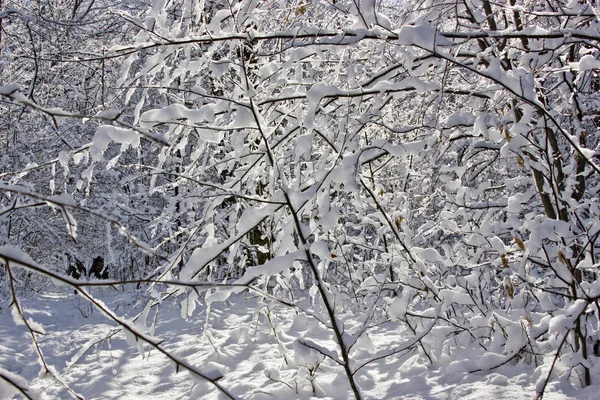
[{"left": 0, "top": 1, "right": 155, "bottom": 284}]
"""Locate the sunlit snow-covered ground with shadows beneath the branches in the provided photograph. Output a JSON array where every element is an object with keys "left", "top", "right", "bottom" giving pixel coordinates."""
[{"left": 0, "top": 291, "right": 598, "bottom": 400}]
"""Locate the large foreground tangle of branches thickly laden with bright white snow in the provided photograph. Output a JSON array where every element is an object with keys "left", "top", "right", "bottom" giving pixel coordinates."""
[{"left": 0, "top": 0, "right": 600, "bottom": 398}]
